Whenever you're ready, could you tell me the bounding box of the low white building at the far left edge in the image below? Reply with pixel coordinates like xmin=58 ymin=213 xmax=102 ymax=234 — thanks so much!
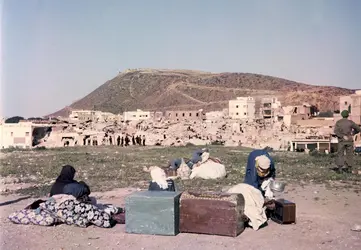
xmin=0 ymin=122 xmax=33 ymax=149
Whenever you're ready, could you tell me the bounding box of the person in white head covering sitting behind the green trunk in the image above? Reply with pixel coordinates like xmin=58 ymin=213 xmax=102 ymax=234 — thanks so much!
xmin=148 ymin=166 xmax=176 ymax=192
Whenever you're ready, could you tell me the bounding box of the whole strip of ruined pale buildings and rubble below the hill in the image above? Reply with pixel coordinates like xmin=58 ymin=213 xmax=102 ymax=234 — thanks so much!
xmin=0 ymin=91 xmax=361 ymax=151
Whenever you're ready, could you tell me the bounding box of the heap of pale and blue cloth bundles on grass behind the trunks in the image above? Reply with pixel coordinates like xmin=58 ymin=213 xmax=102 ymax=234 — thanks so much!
xmin=170 ymin=148 xmax=227 ymax=180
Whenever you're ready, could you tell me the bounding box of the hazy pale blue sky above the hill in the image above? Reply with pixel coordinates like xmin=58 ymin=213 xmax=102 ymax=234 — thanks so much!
xmin=0 ymin=0 xmax=361 ymax=117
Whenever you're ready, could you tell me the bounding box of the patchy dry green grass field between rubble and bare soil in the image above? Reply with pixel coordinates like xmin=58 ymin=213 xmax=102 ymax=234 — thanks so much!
xmin=0 ymin=146 xmax=361 ymax=195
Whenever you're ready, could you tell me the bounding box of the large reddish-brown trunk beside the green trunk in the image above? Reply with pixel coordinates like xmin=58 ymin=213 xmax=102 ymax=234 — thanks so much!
xmin=179 ymin=192 xmax=246 ymax=237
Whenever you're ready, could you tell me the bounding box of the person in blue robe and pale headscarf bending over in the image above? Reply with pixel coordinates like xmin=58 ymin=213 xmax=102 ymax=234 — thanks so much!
xmin=244 ymin=149 xmax=276 ymax=198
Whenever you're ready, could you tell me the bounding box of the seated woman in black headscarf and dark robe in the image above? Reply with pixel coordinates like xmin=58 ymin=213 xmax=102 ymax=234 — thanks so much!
xmin=50 ymin=165 xmax=90 ymax=201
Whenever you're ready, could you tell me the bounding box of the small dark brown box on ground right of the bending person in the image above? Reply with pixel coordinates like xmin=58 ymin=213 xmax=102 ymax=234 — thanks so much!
xmin=271 ymin=199 xmax=296 ymax=224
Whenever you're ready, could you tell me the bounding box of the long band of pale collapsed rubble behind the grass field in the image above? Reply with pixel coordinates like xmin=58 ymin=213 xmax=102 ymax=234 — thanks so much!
xmin=26 ymin=107 xmax=340 ymax=150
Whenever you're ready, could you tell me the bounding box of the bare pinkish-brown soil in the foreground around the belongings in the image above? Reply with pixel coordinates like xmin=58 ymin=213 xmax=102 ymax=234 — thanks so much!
xmin=0 ymin=186 xmax=361 ymax=250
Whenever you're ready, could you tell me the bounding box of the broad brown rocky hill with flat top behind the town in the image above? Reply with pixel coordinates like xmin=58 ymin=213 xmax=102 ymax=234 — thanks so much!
xmin=47 ymin=69 xmax=353 ymax=116
